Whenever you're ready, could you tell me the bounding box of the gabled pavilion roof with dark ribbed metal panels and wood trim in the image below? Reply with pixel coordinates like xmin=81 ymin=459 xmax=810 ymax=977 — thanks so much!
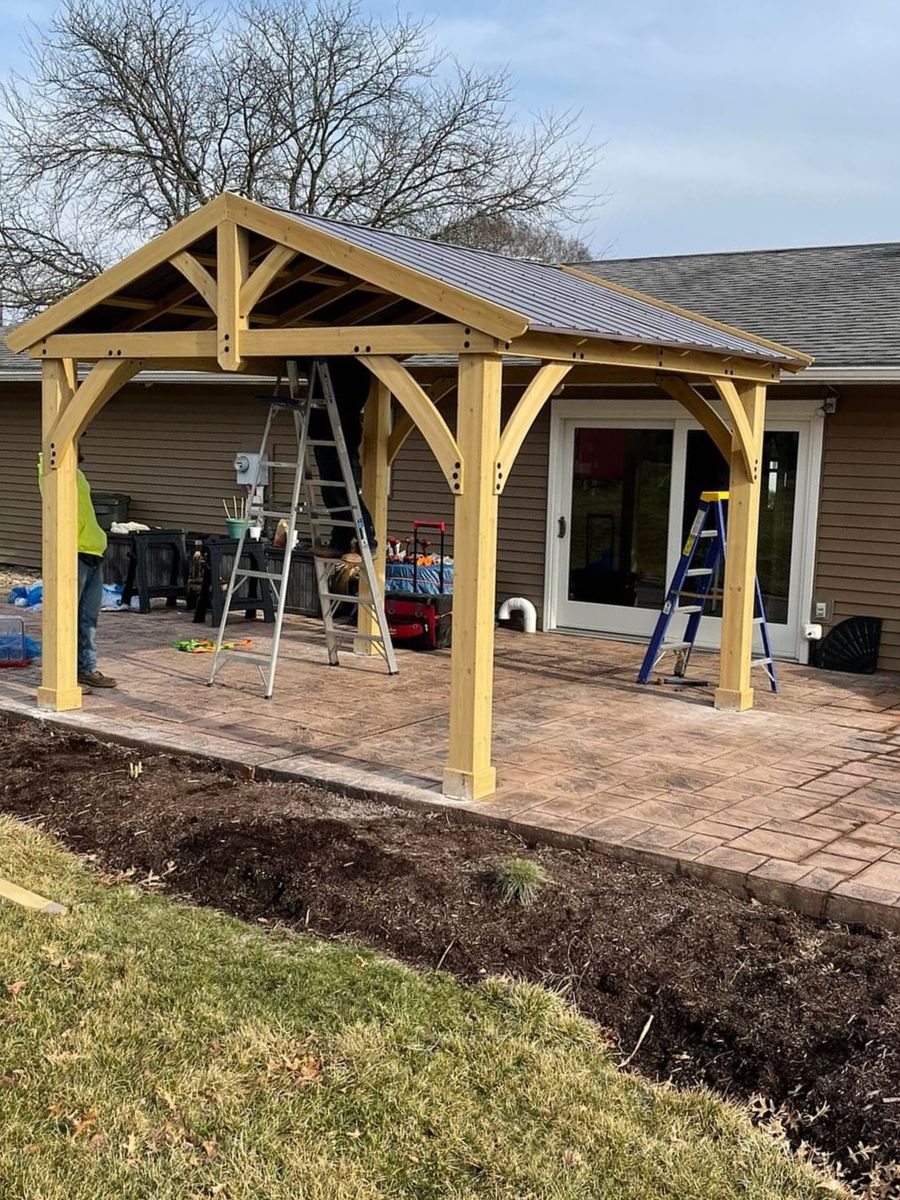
xmin=7 ymin=193 xmax=811 ymax=371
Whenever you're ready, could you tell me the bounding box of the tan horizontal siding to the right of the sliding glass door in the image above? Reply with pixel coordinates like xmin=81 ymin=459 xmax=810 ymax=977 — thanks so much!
xmin=814 ymin=386 xmax=900 ymax=671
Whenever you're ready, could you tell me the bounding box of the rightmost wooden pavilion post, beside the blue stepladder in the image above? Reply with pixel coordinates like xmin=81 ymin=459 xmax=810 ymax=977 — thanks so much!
xmin=715 ymin=383 xmax=766 ymax=712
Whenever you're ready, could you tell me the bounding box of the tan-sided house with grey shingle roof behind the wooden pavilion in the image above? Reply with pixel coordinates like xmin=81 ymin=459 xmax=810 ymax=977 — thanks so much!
xmin=0 ymin=236 xmax=900 ymax=686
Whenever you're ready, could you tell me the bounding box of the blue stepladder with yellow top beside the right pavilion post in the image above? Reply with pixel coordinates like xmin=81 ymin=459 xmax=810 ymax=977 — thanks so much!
xmin=637 ymin=492 xmax=778 ymax=692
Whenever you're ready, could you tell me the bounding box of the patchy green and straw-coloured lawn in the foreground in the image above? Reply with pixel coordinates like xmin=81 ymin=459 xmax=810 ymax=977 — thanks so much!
xmin=0 ymin=817 xmax=834 ymax=1200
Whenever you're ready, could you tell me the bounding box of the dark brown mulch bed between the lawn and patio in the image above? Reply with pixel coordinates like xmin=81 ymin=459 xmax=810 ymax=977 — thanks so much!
xmin=0 ymin=718 xmax=900 ymax=1190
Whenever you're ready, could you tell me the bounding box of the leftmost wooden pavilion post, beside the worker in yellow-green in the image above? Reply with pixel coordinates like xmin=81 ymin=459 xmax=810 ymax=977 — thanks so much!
xmin=37 ymin=359 xmax=82 ymax=713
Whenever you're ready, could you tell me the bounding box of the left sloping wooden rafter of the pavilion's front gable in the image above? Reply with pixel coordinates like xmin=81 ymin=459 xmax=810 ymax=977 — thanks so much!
xmin=6 ymin=196 xmax=226 ymax=352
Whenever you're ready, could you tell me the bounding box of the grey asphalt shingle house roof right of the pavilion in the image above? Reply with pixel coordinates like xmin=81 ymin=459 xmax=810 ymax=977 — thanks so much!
xmin=582 ymin=242 xmax=900 ymax=366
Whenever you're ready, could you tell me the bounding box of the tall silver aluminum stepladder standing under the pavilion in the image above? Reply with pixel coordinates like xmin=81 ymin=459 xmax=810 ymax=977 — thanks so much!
xmin=208 ymin=359 xmax=397 ymax=700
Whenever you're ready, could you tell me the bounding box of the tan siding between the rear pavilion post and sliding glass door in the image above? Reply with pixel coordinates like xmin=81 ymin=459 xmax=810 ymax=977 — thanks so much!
xmin=389 ymin=400 xmax=550 ymax=613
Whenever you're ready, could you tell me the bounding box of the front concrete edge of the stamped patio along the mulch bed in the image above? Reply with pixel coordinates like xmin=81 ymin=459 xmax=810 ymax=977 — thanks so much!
xmin=7 ymin=697 xmax=900 ymax=932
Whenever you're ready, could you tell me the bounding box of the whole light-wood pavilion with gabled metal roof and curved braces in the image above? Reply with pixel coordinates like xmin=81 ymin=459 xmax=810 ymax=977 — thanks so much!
xmin=7 ymin=194 xmax=811 ymax=799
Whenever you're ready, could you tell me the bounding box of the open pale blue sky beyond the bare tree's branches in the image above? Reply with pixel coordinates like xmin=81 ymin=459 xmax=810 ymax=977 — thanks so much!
xmin=0 ymin=0 xmax=900 ymax=257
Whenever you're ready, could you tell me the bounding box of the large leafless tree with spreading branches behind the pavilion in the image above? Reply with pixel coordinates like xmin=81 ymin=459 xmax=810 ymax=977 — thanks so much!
xmin=0 ymin=0 xmax=607 ymax=313
